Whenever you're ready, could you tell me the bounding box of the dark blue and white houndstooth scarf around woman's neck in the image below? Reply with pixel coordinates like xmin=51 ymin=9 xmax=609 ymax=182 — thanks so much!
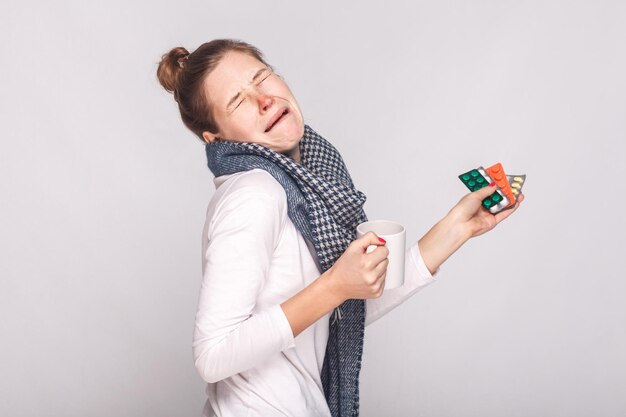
xmin=206 ymin=125 xmax=367 ymax=417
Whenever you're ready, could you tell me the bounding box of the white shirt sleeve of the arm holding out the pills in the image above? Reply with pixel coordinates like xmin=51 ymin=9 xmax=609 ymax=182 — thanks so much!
xmin=365 ymin=242 xmax=439 ymax=326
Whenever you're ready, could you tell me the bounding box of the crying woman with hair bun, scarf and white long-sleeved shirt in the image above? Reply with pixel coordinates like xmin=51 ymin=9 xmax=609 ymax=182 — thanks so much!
xmin=157 ymin=39 xmax=523 ymax=417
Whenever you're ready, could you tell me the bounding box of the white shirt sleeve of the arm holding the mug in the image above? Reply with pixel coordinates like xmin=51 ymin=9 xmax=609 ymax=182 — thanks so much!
xmin=192 ymin=184 xmax=295 ymax=382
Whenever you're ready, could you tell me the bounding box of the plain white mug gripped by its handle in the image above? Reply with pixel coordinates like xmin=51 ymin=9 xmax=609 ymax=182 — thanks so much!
xmin=356 ymin=220 xmax=406 ymax=289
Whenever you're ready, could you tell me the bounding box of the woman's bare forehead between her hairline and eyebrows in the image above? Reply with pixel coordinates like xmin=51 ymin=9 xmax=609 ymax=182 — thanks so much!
xmin=204 ymin=52 xmax=265 ymax=105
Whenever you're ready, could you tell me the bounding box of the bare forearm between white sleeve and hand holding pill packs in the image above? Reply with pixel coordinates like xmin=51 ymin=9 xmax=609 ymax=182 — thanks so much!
xmin=417 ymin=215 xmax=471 ymax=274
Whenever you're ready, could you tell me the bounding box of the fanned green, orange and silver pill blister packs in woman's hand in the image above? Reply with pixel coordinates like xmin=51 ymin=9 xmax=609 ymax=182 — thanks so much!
xmin=459 ymin=162 xmax=526 ymax=214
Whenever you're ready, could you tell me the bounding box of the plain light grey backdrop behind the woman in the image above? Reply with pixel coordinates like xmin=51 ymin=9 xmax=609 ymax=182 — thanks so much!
xmin=0 ymin=0 xmax=626 ymax=417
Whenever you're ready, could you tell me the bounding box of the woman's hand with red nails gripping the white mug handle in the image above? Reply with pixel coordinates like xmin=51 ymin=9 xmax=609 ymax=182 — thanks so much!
xmin=324 ymin=232 xmax=389 ymax=305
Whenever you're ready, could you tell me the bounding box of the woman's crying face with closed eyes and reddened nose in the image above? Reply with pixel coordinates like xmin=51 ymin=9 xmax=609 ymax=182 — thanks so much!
xmin=202 ymin=52 xmax=304 ymax=162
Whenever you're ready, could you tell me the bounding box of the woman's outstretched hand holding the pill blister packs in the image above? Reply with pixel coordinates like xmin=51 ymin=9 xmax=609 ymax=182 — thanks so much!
xmin=448 ymin=186 xmax=524 ymax=238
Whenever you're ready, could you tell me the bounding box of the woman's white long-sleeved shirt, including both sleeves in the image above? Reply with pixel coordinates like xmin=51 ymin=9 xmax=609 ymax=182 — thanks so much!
xmin=192 ymin=169 xmax=437 ymax=417
